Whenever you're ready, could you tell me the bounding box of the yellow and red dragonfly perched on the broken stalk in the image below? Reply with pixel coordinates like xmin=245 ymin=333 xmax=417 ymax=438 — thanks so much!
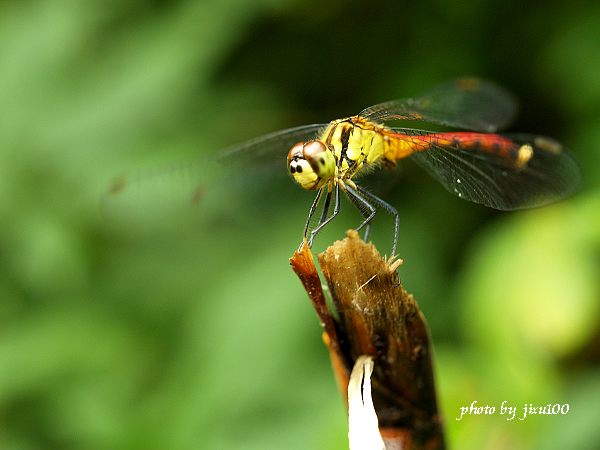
xmin=109 ymin=78 xmax=581 ymax=256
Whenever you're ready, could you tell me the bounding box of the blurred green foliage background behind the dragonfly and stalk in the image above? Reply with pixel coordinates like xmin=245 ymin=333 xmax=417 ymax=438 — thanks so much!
xmin=0 ymin=0 xmax=600 ymax=450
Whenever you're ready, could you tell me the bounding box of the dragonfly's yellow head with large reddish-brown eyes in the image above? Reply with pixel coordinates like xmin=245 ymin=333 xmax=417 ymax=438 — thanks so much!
xmin=288 ymin=140 xmax=336 ymax=189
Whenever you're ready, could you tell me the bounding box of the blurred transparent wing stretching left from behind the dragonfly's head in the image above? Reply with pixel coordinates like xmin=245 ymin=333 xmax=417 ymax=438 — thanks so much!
xmin=101 ymin=124 xmax=326 ymax=221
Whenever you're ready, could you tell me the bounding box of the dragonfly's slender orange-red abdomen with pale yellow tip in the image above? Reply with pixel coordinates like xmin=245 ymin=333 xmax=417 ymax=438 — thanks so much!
xmin=385 ymin=130 xmax=532 ymax=167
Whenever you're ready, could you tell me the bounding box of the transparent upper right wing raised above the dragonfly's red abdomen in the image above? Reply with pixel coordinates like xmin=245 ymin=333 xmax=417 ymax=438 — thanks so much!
xmin=359 ymin=78 xmax=517 ymax=132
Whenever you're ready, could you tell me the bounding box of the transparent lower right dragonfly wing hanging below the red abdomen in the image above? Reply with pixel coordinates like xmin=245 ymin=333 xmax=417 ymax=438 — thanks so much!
xmin=410 ymin=130 xmax=581 ymax=210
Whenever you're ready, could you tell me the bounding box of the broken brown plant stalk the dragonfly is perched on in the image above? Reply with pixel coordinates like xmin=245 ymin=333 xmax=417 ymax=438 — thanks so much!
xmin=290 ymin=231 xmax=444 ymax=450
